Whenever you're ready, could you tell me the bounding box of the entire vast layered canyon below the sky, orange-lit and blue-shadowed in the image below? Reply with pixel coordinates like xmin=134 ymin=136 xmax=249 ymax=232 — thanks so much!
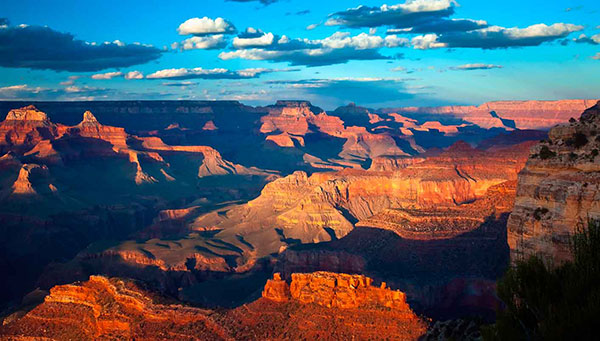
xmin=0 ymin=100 xmax=600 ymax=339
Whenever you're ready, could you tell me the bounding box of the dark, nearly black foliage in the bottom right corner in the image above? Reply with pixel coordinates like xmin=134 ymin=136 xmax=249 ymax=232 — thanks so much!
xmin=482 ymin=221 xmax=600 ymax=340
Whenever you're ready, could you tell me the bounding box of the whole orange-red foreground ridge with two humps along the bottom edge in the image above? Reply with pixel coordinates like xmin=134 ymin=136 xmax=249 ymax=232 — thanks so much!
xmin=0 ymin=273 xmax=426 ymax=340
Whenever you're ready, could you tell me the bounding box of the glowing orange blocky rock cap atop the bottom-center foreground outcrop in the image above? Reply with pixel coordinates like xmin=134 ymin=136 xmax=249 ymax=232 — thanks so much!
xmin=262 ymin=271 xmax=416 ymax=310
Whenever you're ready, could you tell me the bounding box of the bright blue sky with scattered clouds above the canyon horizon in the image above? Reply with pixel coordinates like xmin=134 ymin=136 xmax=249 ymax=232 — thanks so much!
xmin=0 ymin=0 xmax=600 ymax=109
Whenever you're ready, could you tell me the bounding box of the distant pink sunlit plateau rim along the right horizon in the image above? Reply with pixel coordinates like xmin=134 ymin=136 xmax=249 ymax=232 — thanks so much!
xmin=384 ymin=100 xmax=596 ymax=130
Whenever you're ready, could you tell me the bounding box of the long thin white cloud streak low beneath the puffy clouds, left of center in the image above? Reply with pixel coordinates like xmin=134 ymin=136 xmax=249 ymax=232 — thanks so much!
xmin=146 ymin=67 xmax=297 ymax=80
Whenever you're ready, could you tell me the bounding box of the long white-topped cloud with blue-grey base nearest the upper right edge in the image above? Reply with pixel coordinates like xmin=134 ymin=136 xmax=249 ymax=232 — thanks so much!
xmin=411 ymin=23 xmax=583 ymax=49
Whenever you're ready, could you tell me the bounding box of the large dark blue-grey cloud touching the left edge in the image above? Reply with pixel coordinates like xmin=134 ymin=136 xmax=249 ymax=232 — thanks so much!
xmin=0 ymin=25 xmax=162 ymax=72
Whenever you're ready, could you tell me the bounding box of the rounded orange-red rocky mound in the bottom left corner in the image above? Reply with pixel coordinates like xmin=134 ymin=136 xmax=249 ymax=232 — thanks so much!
xmin=0 ymin=276 xmax=230 ymax=340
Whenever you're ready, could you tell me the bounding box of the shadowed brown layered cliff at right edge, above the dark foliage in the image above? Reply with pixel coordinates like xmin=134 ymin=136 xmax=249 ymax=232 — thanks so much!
xmin=508 ymin=100 xmax=600 ymax=262
